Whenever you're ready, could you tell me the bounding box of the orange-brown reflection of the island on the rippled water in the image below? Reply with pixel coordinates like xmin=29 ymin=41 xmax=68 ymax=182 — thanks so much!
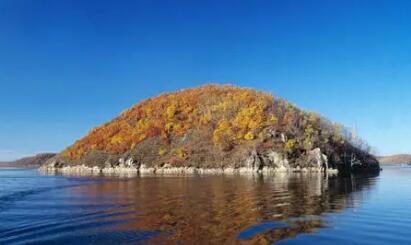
xmin=82 ymin=174 xmax=380 ymax=244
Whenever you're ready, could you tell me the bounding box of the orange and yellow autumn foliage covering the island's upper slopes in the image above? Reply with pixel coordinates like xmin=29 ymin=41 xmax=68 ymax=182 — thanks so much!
xmin=63 ymin=85 xmax=342 ymax=159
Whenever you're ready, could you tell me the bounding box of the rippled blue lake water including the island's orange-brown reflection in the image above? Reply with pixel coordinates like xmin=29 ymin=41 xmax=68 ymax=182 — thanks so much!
xmin=0 ymin=166 xmax=411 ymax=244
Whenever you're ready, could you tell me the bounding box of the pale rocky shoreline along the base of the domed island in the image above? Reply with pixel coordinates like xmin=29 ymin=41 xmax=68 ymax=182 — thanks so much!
xmin=41 ymin=148 xmax=338 ymax=175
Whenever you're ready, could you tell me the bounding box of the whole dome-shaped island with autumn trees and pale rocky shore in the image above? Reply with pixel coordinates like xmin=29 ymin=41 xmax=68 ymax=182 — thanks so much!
xmin=42 ymin=85 xmax=380 ymax=174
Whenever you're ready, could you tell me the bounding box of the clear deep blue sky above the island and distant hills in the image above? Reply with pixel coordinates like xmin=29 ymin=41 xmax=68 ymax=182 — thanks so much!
xmin=0 ymin=0 xmax=411 ymax=160
